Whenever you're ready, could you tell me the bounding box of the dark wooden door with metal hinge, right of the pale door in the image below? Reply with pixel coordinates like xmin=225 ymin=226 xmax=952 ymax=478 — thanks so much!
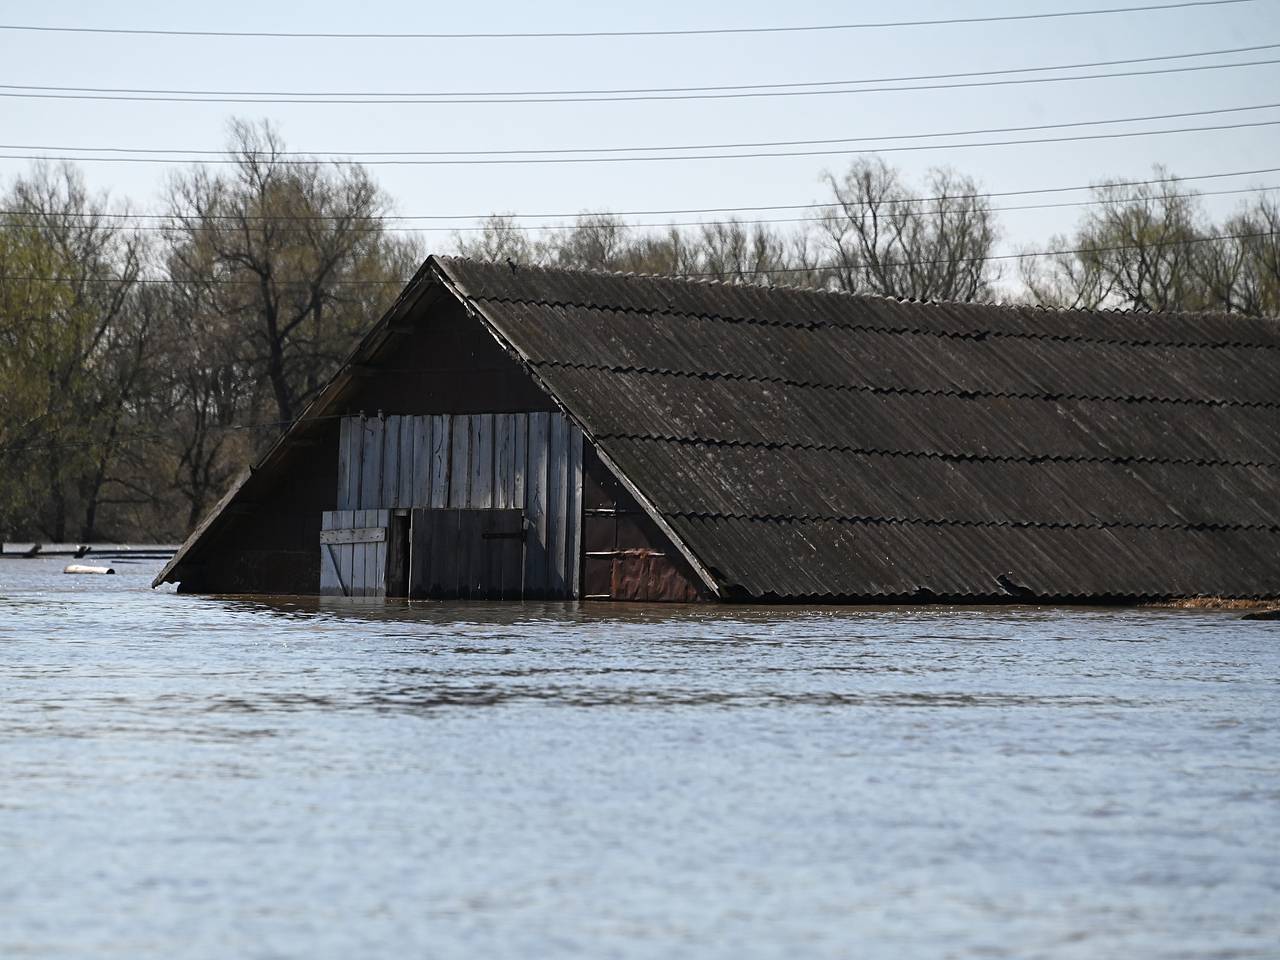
xmin=408 ymin=508 xmax=525 ymax=600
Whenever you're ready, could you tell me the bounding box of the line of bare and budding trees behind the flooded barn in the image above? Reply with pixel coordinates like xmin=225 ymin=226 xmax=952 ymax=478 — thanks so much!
xmin=0 ymin=120 xmax=1280 ymax=541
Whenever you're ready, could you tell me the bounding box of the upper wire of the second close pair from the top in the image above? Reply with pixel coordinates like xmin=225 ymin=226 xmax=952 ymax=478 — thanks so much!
xmin=0 ymin=102 xmax=1280 ymax=164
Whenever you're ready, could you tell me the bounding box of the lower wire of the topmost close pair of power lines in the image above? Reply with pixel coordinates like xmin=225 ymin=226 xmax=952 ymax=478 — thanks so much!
xmin=0 ymin=59 xmax=1280 ymax=106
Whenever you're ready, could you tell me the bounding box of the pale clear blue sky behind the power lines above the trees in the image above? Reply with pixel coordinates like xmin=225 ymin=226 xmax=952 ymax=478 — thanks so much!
xmin=0 ymin=0 xmax=1280 ymax=271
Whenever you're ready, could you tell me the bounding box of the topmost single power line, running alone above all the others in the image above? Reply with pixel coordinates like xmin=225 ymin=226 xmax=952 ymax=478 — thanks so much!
xmin=0 ymin=0 xmax=1254 ymax=40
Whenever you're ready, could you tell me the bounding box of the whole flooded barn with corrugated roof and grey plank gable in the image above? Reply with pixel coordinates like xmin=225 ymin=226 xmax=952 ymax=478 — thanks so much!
xmin=156 ymin=257 xmax=1280 ymax=603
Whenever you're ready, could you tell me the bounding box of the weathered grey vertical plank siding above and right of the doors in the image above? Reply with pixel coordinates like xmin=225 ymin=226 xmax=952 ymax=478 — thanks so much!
xmin=337 ymin=412 xmax=582 ymax=599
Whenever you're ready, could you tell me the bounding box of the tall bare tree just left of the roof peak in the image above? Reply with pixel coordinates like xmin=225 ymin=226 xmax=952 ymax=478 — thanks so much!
xmin=168 ymin=120 xmax=416 ymax=421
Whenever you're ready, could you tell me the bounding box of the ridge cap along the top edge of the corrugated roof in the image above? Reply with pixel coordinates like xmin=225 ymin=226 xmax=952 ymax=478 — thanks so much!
xmin=434 ymin=255 xmax=1280 ymax=335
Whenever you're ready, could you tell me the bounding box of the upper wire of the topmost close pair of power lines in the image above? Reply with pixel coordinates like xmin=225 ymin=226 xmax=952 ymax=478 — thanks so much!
xmin=0 ymin=44 xmax=1280 ymax=101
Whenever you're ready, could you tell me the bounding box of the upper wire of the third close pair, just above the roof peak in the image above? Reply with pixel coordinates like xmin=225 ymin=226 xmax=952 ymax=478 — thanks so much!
xmin=0 ymin=166 xmax=1280 ymax=229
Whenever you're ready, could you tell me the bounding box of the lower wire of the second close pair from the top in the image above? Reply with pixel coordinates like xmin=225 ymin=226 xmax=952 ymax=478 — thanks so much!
xmin=0 ymin=120 xmax=1280 ymax=166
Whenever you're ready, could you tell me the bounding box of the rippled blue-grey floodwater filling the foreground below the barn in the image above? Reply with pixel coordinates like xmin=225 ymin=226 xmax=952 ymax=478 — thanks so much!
xmin=0 ymin=561 xmax=1280 ymax=960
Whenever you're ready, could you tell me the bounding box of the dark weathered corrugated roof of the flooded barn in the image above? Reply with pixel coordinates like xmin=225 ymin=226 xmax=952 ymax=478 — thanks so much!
xmin=154 ymin=257 xmax=1280 ymax=600
